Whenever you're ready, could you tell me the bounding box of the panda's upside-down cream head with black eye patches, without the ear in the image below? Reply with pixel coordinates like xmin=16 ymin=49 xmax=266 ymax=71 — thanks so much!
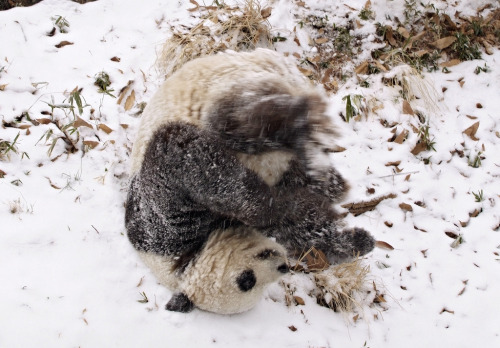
xmin=183 ymin=227 xmax=289 ymax=314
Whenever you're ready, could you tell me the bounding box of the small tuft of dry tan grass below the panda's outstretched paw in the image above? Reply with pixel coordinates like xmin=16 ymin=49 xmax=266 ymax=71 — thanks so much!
xmin=314 ymin=258 xmax=370 ymax=312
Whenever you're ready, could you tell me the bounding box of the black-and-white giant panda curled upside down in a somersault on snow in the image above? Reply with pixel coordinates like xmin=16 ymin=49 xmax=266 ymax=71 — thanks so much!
xmin=125 ymin=49 xmax=374 ymax=313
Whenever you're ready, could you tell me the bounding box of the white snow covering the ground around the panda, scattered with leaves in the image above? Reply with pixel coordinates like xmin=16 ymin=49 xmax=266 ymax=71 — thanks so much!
xmin=0 ymin=0 xmax=500 ymax=347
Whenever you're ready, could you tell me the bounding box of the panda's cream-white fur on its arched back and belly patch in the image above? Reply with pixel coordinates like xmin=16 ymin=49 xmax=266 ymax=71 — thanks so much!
xmin=131 ymin=49 xmax=334 ymax=179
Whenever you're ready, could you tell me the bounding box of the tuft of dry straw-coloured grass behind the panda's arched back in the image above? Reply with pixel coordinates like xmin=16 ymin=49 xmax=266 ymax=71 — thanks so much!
xmin=157 ymin=0 xmax=272 ymax=78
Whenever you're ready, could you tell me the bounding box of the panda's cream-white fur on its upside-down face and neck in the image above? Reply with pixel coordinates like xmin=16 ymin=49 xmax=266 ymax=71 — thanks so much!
xmin=139 ymin=227 xmax=286 ymax=314
